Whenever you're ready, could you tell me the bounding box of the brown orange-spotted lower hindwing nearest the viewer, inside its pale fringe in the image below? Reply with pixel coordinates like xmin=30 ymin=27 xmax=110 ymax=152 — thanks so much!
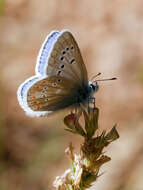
xmin=27 ymin=76 xmax=80 ymax=111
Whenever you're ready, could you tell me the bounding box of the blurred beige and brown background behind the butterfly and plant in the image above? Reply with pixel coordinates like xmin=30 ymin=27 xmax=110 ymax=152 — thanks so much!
xmin=0 ymin=0 xmax=143 ymax=190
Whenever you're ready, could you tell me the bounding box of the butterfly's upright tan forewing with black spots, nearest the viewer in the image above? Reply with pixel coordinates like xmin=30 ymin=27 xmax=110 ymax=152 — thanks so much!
xmin=38 ymin=31 xmax=88 ymax=84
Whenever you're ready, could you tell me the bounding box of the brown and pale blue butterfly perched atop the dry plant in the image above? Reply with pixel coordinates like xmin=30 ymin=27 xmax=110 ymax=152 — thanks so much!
xmin=17 ymin=30 xmax=101 ymax=116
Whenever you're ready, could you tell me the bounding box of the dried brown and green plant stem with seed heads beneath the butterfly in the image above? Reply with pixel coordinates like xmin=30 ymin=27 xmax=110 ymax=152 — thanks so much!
xmin=54 ymin=108 xmax=119 ymax=190
